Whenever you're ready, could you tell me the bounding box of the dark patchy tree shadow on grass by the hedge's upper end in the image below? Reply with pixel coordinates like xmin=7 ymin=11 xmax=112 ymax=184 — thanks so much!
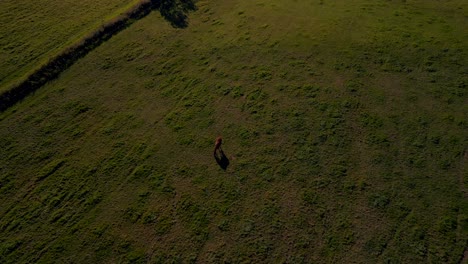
xmin=153 ymin=0 xmax=197 ymax=28
